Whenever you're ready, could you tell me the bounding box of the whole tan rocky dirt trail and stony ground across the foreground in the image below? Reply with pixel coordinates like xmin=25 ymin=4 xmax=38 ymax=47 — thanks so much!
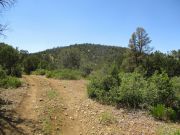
xmin=0 ymin=75 xmax=180 ymax=135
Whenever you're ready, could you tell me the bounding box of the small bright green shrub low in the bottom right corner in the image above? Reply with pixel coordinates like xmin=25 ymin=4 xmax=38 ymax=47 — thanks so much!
xmin=151 ymin=104 xmax=177 ymax=120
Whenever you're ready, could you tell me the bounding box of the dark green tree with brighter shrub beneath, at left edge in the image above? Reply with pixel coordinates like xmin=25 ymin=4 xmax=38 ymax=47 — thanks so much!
xmin=0 ymin=43 xmax=22 ymax=88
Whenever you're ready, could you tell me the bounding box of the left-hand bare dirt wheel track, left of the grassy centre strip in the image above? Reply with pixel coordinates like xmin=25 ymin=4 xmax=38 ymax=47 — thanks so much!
xmin=15 ymin=76 xmax=38 ymax=135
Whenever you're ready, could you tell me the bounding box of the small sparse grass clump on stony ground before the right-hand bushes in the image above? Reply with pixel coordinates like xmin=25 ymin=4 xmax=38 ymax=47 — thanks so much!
xmin=100 ymin=112 xmax=116 ymax=125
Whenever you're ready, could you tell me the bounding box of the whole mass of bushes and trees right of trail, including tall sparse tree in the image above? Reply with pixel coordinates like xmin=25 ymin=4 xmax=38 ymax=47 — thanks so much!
xmin=88 ymin=28 xmax=180 ymax=121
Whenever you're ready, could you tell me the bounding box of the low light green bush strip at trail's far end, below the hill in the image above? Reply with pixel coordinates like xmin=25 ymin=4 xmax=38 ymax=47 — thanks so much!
xmin=46 ymin=69 xmax=82 ymax=80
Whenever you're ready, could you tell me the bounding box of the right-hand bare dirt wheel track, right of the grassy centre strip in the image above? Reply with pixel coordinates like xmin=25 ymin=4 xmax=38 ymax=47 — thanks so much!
xmin=42 ymin=77 xmax=87 ymax=135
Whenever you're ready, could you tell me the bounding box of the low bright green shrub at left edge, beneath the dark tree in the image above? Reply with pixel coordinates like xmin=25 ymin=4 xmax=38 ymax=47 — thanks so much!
xmin=0 ymin=76 xmax=21 ymax=88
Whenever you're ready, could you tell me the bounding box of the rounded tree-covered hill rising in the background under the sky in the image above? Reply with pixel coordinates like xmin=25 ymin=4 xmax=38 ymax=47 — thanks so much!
xmin=31 ymin=43 xmax=127 ymax=69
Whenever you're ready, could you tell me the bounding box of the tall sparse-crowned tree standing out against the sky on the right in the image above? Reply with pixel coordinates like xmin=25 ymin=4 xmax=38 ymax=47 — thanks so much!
xmin=121 ymin=27 xmax=152 ymax=72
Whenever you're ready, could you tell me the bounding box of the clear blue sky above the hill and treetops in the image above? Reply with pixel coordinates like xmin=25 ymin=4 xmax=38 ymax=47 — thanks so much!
xmin=0 ymin=0 xmax=180 ymax=53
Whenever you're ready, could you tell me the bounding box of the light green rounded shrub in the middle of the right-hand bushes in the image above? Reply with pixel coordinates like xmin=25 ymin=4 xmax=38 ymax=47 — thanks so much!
xmin=118 ymin=72 xmax=147 ymax=108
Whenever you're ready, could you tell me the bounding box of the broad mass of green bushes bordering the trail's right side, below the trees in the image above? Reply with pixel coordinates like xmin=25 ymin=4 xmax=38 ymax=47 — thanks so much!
xmin=88 ymin=69 xmax=180 ymax=120
